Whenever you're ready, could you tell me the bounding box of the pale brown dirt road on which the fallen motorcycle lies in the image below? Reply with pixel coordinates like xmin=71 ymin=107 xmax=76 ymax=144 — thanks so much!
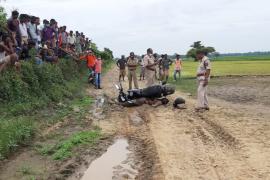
xmin=93 ymin=66 xmax=270 ymax=180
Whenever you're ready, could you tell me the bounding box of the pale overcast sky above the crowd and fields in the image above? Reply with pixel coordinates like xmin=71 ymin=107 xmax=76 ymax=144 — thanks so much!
xmin=0 ymin=0 xmax=270 ymax=56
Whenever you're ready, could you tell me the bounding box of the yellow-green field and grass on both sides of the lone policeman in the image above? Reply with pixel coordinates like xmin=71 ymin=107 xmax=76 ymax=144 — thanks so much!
xmin=170 ymin=56 xmax=270 ymax=95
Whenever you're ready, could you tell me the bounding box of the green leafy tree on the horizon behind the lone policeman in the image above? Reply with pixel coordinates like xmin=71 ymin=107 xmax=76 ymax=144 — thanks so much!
xmin=187 ymin=41 xmax=216 ymax=60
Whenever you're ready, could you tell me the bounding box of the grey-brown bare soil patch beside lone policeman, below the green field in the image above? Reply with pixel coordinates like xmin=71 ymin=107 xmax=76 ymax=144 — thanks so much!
xmin=209 ymin=76 xmax=270 ymax=106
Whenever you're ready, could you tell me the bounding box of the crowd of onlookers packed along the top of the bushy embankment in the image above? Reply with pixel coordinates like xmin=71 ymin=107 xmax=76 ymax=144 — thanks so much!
xmin=0 ymin=10 xmax=102 ymax=88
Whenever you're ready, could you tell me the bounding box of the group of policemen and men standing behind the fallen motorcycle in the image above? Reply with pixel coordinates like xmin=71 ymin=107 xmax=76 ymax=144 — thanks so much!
xmin=116 ymin=49 xmax=183 ymax=89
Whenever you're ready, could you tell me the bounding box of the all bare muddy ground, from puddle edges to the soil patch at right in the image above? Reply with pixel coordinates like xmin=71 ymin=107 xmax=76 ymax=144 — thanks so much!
xmin=0 ymin=68 xmax=270 ymax=180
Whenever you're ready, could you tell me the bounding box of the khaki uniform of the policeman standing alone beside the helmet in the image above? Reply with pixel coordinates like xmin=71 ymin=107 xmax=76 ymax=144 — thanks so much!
xmin=197 ymin=56 xmax=211 ymax=108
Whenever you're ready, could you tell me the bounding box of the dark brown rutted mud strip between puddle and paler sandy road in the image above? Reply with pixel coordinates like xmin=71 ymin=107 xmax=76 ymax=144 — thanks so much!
xmin=91 ymin=102 xmax=164 ymax=180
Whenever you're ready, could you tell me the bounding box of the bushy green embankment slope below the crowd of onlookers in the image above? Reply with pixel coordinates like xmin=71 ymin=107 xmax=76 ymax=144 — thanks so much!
xmin=0 ymin=59 xmax=112 ymax=159
